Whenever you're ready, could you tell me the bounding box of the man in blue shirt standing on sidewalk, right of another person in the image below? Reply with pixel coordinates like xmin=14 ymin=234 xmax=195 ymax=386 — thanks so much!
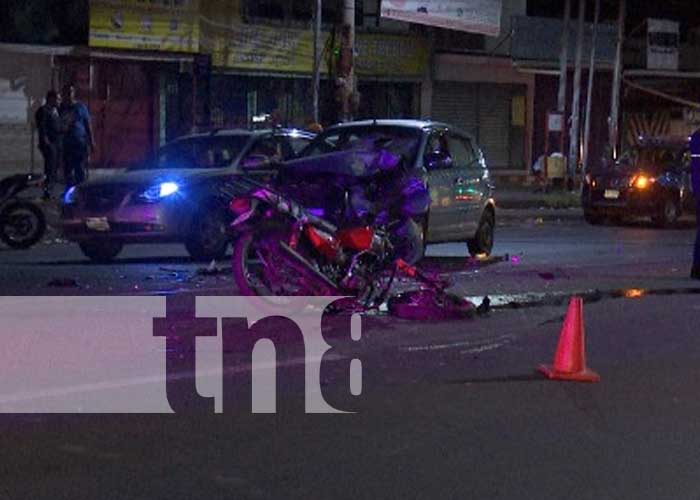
xmin=60 ymin=84 xmax=95 ymax=188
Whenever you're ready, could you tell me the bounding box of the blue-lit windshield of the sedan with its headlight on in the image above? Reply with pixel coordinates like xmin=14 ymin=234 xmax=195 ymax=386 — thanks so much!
xmin=136 ymin=135 xmax=249 ymax=169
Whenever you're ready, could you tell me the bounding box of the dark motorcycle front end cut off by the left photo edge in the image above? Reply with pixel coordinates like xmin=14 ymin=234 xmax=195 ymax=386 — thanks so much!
xmin=0 ymin=174 xmax=46 ymax=249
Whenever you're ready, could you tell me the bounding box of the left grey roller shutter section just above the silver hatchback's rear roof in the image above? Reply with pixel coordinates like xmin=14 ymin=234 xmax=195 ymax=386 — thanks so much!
xmin=432 ymin=82 xmax=478 ymax=137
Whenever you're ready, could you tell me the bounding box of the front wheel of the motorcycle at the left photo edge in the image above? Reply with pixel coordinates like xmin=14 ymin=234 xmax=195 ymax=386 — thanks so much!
xmin=0 ymin=201 xmax=46 ymax=249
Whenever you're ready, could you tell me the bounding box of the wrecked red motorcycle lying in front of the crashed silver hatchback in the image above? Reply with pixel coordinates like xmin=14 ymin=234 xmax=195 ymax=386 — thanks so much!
xmin=230 ymin=180 xmax=474 ymax=320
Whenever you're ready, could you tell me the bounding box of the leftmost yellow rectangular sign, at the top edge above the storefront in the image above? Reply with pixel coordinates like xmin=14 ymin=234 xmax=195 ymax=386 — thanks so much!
xmin=90 ymin=0 xmax=199 ymax=53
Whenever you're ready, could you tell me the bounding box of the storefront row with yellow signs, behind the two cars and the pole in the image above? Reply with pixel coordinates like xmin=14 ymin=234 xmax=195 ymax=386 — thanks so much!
xmin=84 ymin=0 xmax=429 ymax=168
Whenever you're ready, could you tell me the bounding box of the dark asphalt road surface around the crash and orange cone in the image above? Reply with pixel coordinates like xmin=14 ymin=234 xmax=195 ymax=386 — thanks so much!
xmin=0 ymin=217 xmax=700 ymax=500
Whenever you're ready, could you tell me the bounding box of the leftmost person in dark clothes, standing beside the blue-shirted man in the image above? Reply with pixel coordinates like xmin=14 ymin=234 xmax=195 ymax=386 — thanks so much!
xmin=34 ymin=90 xmax=61 ymax=200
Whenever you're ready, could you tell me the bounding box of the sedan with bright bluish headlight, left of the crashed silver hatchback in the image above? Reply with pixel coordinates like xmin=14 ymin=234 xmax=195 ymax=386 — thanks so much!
xmin=62 ymin=129 xmax=314 ymax=262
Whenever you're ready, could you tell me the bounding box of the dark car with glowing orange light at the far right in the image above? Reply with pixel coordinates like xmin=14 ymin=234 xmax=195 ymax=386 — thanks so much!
xmin=581 ymin=141 xmax=692 ymax=227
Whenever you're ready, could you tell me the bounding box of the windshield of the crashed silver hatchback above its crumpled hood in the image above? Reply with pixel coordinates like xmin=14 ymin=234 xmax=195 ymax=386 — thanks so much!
xmin=301 ymin=125 xmax=421 ymax=159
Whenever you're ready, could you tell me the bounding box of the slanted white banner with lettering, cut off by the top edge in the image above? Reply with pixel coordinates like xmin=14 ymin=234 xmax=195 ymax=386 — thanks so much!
xmin=381 ymin=0 xmax=502 ymax=36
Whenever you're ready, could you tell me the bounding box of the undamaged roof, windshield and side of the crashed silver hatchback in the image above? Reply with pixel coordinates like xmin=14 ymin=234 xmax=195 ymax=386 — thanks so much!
xmin=299 ymin=120 xmax=496 ymax=255
